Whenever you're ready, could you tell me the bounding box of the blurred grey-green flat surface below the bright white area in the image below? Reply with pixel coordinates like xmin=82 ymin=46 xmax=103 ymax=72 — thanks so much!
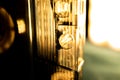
xmin=83 ymin=41 xmax=120 ymax=80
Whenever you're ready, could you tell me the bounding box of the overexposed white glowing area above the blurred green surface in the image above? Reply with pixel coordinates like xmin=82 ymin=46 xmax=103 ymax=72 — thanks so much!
xmin=88 ymin=0 xmax=120 ymax=50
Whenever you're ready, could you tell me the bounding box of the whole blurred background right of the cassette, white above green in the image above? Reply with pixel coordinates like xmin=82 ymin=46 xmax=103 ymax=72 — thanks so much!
xmin=83 ymin=0 xmax=120 ymax=80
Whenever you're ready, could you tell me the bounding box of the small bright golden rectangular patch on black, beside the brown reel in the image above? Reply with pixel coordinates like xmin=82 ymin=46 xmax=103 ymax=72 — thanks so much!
xmin=17 ymin=19 xmax=26 ymax=34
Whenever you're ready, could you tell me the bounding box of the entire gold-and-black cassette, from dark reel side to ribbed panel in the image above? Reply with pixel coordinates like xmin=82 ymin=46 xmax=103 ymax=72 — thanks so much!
xmin=0 ymin=0 xmax=86 ymax=80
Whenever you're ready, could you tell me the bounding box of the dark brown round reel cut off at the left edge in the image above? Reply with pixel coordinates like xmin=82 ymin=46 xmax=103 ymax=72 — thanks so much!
xmin=0 ymin=7 xmax=15 ymax=54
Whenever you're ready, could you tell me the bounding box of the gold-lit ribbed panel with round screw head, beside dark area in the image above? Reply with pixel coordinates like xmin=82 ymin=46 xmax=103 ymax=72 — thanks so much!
xmin=35 ymin=0 xmax=86 ymax=72
